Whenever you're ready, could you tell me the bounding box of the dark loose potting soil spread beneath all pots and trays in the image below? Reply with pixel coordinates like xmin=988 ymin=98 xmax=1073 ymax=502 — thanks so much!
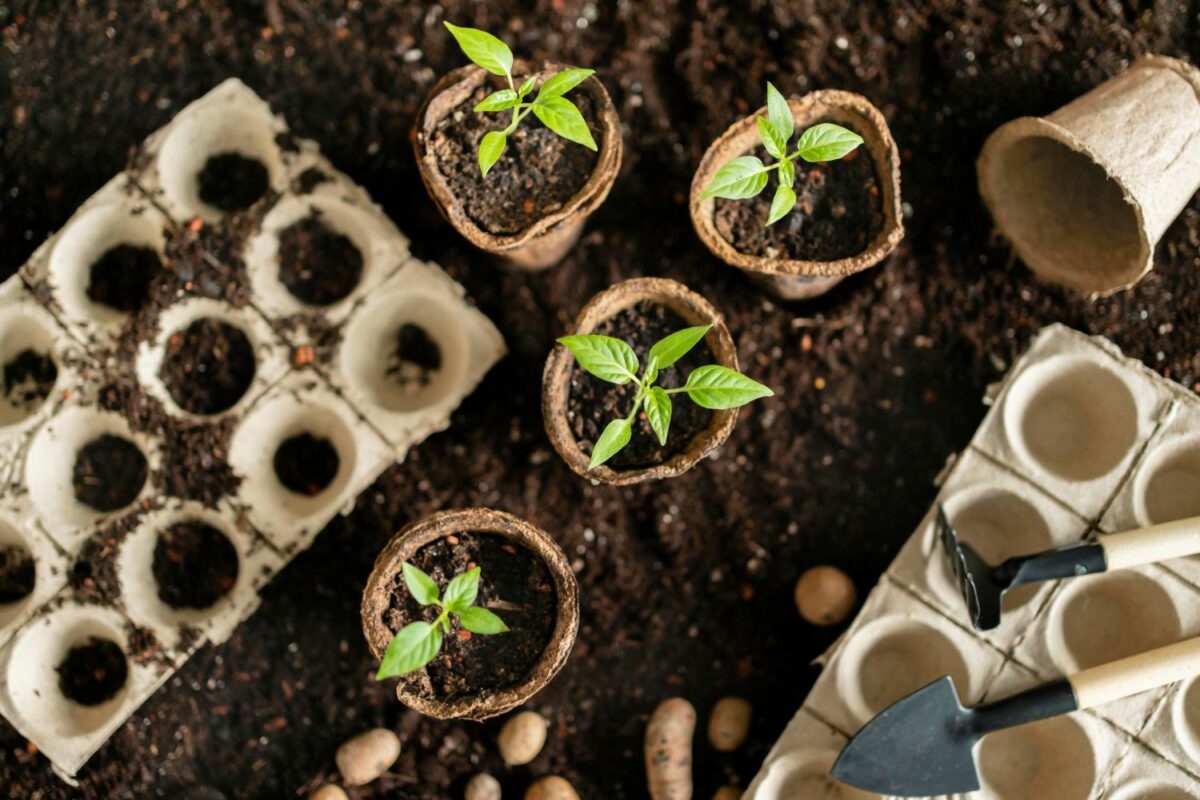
xmin=0 ymin=0 xmax=1200 ymax=800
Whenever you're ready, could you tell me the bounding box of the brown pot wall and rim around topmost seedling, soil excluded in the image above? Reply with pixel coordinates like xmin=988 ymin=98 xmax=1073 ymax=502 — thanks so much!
xmin=413 ymin=61 xmax=622 ymax=270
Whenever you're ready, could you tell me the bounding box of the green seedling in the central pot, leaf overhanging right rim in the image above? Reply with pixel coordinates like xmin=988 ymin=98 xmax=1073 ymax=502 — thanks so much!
xmin=558 ymin=325 xmax=775 ymax=469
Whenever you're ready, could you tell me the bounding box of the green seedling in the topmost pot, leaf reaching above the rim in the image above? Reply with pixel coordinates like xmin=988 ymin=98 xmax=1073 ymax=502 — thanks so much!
xmin=445 ymin=23 xmax=596 ymax=178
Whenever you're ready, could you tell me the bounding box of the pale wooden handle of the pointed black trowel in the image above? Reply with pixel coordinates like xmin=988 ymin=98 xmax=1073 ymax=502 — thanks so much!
xmin=1067 ymin=636 xmax=1200 ymax=709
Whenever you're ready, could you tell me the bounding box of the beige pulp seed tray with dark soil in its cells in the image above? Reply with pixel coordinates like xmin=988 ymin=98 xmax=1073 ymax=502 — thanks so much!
xmin=0 ymin=80 xmax=504 ymax=777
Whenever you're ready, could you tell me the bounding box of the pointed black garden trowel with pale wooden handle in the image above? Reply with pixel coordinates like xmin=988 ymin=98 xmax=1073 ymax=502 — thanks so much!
xmin=830 ymin=637 xmax=1200 ymax=798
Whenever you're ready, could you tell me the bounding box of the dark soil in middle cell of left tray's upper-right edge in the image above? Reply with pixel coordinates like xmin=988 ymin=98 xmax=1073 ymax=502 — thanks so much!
xmin=280 ymin=212 xmax=362 ymax=306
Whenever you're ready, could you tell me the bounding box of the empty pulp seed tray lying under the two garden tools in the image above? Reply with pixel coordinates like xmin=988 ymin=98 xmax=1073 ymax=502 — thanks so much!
xmin=746 ymin=325 xmax=1200 ymax=800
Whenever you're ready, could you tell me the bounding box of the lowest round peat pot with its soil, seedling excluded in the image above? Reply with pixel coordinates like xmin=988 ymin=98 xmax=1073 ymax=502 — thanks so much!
xmin=362 ymin=509 xmax=580 ymax=721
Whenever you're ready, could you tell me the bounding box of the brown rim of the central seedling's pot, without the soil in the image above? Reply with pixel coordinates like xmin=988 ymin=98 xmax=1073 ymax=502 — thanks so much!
xmin=541 ymin=278 xmax=738 ymax=486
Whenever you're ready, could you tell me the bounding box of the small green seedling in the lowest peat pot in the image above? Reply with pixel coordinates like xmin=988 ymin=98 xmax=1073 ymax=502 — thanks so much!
xmin=376 ymin=563 xmax=509 ymax=680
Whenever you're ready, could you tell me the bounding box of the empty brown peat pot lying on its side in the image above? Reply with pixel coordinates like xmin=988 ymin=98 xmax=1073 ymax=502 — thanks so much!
xmin=978 ymin=55 xmax=1200 ymax=295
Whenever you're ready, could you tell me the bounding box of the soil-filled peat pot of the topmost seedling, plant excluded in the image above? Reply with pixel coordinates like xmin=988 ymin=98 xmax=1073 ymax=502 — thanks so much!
xmin=413 ymin=61 xmax=622 ymax=270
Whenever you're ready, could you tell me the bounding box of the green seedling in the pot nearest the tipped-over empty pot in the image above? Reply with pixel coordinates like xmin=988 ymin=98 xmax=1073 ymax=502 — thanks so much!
xmin=700 ymin=83 xmax=863 ymax=225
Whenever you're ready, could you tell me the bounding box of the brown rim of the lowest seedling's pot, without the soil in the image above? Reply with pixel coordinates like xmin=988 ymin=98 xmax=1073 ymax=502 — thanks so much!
xmin=362 ymin=509 xmax=580 ymax=721
